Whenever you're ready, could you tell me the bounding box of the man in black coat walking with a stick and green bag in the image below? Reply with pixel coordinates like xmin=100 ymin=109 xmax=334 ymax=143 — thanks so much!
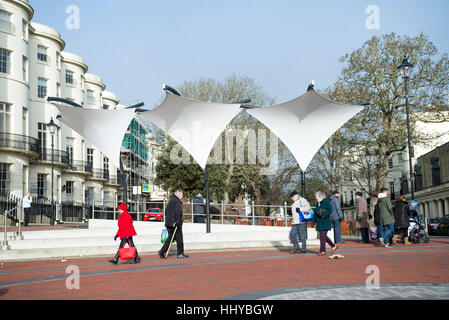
xmin=158 ymin=190 xmax=189 ymax=259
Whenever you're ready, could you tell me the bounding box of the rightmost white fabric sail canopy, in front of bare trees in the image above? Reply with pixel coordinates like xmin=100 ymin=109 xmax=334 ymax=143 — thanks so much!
xmin=247 ymin=90 xmax=363 ymax=171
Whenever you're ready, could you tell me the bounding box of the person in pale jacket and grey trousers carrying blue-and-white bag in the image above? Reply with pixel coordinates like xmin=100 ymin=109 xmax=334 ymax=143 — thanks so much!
xmin=290 ymin=190 xmax=310 ymax=254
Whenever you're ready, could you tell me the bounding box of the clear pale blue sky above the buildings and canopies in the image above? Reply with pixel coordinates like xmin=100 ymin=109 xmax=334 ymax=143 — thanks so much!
xmin=30 ymin=0 xmax=449 ymax=107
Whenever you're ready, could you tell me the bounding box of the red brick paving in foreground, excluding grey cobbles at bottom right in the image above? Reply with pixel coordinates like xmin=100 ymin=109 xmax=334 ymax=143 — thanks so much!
xmin=0 ymin=238 xmax=449 ymax=300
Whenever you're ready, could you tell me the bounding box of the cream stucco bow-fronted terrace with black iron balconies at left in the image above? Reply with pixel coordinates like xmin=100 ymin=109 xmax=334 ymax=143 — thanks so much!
xmin=0 ymin=0 xmax=152 ymax=222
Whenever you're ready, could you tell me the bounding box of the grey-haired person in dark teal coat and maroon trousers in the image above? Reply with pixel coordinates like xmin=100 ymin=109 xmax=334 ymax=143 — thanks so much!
xmin=312 ymin=191 xmax=338 ymax=256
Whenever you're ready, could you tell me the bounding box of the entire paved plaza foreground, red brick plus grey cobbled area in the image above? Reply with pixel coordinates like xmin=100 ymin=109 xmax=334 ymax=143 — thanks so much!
xmin=0 ymin=237 xmax=449 ymax=300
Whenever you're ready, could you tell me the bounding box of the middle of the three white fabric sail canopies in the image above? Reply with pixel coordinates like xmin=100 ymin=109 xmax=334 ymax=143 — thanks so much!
xmin=141 ymin=93 xmax=240 ymax=170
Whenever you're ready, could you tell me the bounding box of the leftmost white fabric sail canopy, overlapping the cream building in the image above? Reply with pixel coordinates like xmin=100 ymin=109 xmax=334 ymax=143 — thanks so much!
xmin=52 ymin=102 xmax=135 ymax=168
